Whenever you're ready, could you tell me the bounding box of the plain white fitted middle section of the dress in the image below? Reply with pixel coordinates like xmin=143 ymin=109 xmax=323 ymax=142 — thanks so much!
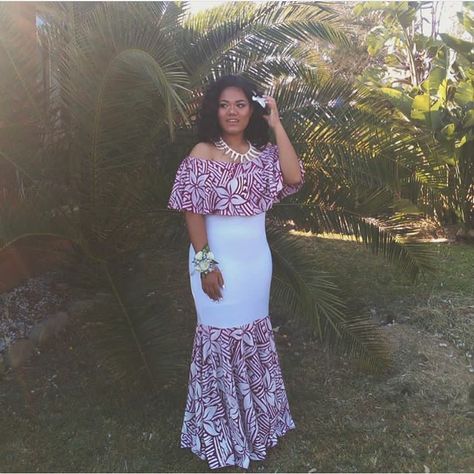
xmin=188 ymin=212 xmax=272 ymax=328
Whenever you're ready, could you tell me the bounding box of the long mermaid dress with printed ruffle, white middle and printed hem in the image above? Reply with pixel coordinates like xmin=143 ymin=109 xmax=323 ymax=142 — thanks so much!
xmin=168 ymin=144 xmax=304 ymax=469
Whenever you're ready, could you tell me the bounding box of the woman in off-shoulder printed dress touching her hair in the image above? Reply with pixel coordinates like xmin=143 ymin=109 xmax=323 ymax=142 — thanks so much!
xmin=168 ymin=76 xmax=304 ymax=469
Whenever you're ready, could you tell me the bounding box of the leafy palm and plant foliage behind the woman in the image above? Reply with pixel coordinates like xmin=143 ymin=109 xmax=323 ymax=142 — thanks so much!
xmin=0 ymin=2 xmax=473 ymax=392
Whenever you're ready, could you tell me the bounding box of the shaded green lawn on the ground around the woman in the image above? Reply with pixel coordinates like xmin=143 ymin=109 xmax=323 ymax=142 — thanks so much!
xmin=0 ymin=236 xmax=474 ymax=472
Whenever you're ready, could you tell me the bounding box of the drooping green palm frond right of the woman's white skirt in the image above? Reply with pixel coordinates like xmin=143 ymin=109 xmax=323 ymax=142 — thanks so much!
xmin=267 ymin=225 xmax=391 ymax=371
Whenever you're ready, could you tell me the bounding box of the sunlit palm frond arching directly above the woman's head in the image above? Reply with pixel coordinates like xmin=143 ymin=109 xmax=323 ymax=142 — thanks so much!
xmin=181 ymin=2 xmax=347 ymax=85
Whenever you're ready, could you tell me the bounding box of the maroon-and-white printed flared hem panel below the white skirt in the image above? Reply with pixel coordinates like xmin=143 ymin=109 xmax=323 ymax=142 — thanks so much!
xmin=180 ymin=316 xmax=295 ymax=469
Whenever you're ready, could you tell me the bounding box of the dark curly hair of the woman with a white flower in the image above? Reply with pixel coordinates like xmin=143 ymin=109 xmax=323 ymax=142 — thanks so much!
xmin=197 ymin=75 xmax=269 ymax=149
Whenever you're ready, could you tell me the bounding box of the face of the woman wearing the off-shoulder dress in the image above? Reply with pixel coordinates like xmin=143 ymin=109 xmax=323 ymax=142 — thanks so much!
xmin=217 ymin=87 xmax=253 ymax=135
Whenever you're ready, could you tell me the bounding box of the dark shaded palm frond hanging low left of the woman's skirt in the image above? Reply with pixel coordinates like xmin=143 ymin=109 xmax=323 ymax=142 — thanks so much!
xmin=63 ymin=254 xmax=192 ymax=395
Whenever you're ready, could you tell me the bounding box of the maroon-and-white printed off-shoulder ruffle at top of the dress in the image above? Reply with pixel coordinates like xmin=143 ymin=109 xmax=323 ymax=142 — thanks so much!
xmin=168 ymin=145 xmax=304 ymax=216
